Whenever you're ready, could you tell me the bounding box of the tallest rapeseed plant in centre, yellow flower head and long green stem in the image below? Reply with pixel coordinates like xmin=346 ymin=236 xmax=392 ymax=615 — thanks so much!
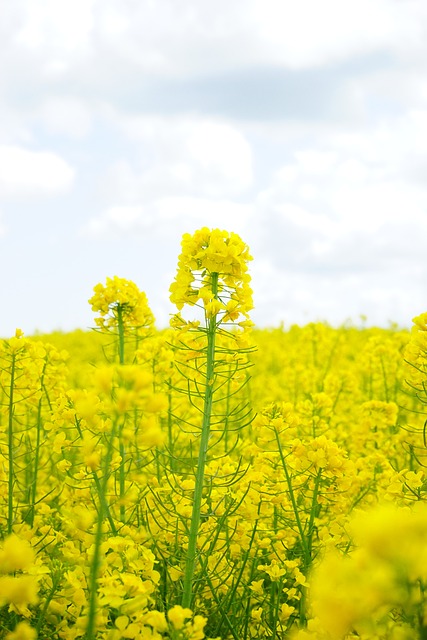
xmin=170 ymin=228 xmax=252 ymax=608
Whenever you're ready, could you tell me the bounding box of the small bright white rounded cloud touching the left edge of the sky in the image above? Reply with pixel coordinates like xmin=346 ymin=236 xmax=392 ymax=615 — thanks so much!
xmin=0 ymin=145 xmax=75 ymax=198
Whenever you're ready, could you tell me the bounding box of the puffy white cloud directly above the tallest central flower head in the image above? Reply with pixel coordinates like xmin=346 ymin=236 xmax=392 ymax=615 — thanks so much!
xmin=108 ymin=117 xmax=253 ymax=201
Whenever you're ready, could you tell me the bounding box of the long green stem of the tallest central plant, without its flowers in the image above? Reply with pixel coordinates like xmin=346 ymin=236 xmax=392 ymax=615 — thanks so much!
xmin=181 ymin=273 xmax=218 ymax=608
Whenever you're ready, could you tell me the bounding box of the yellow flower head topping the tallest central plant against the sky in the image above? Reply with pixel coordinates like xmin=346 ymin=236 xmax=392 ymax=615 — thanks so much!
xmin=170 ymin=227 xmax=253 ymax=322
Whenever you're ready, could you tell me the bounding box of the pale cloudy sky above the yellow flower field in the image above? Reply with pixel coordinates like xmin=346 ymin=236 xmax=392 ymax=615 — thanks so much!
xmin=0 ymin=0 xmax=427 ymax=337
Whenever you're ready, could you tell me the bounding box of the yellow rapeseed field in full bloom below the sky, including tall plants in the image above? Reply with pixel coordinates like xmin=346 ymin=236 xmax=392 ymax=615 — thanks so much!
xmin=0 ymin=229 xmax=427 ymax=640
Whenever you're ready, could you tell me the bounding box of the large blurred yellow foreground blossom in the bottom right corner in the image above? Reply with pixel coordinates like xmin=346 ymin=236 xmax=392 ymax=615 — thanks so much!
xmin=312 ymin=502 xmax=427 ymax=640
